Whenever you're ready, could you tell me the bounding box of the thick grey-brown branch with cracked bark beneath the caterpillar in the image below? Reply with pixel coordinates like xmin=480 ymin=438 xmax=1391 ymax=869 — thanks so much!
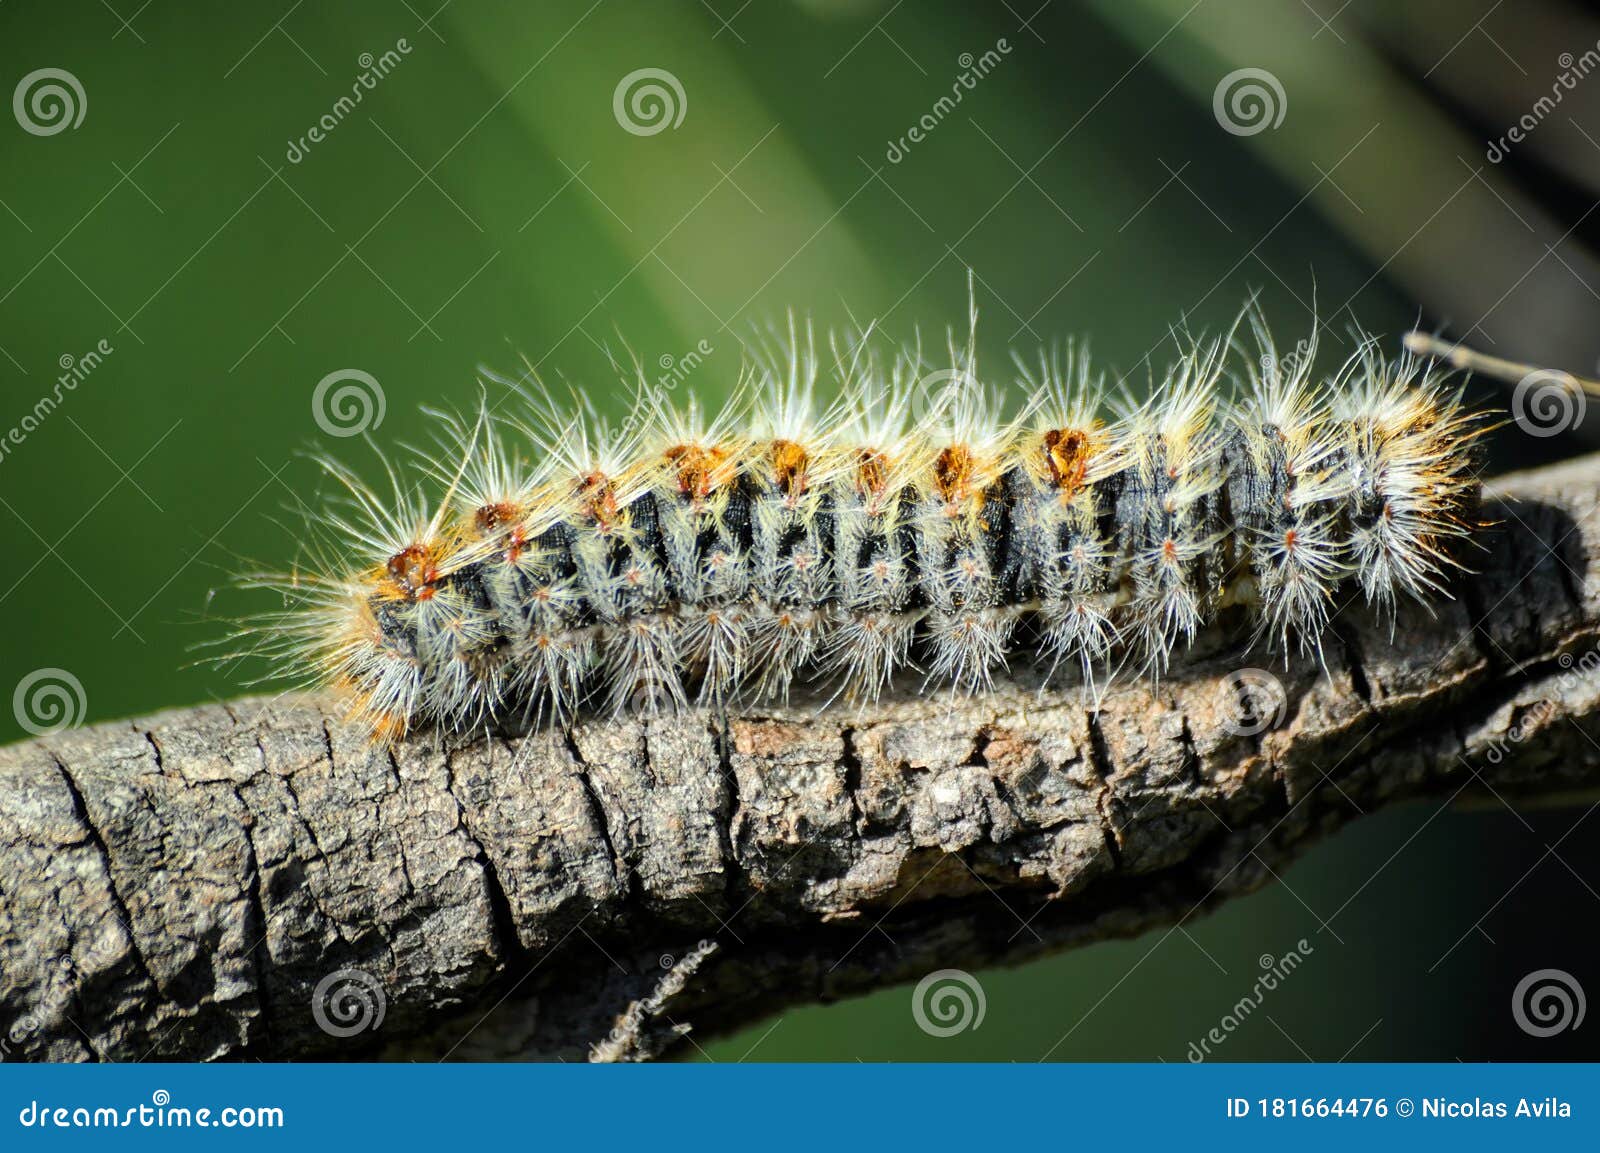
xmin=9 ymin=457 xmax=1600 ymax=1060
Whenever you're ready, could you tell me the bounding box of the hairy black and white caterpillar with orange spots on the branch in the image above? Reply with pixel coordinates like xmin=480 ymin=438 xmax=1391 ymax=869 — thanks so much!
xmin=243 ymin=305 xmax=1486 ymax=740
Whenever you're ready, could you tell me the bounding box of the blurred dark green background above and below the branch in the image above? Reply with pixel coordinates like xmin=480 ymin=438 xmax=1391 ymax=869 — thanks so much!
xmin=0 ymin=0 xmax=1600 ymax=1060
